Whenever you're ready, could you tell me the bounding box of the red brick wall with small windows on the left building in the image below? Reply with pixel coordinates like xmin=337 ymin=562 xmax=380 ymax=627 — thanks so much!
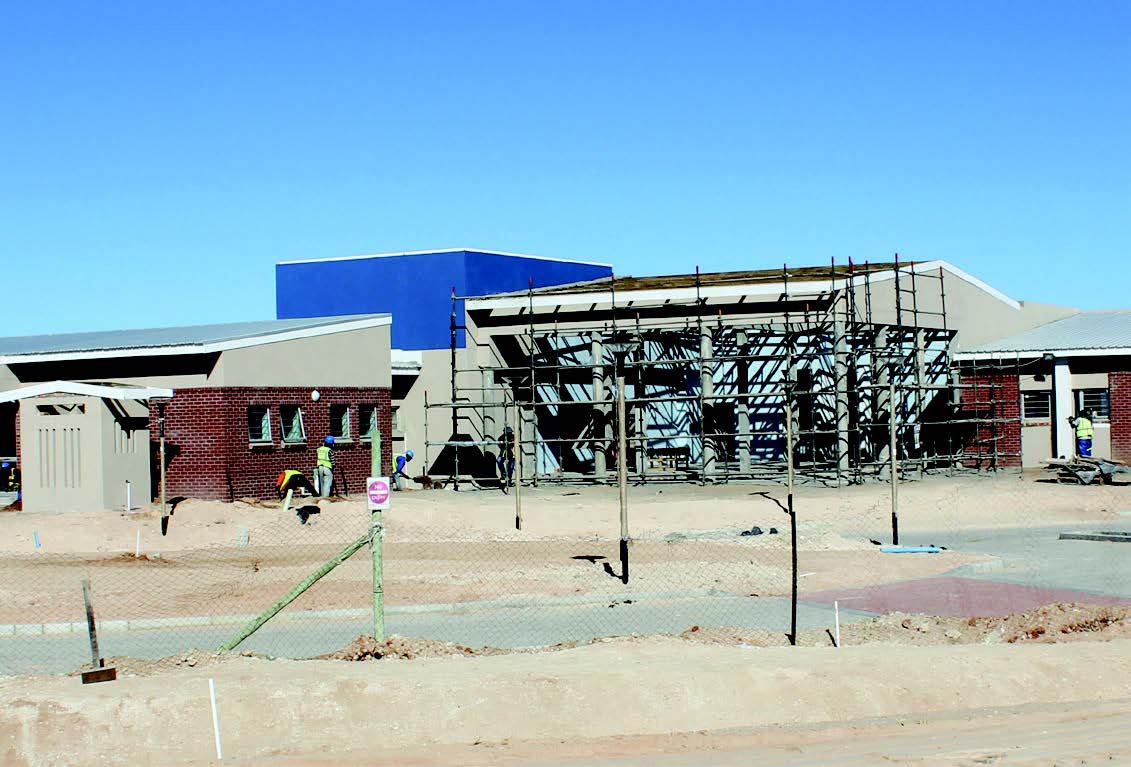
xmin=149 ymin=387 xmax=392 ymax=500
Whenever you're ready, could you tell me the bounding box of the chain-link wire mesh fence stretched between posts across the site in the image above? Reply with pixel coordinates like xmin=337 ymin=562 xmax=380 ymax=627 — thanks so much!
xmin=0 ymin=472 xmax=1131 ymax=674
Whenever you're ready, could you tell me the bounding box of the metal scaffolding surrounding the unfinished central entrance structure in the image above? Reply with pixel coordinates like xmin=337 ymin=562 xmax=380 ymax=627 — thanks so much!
xmin=425 ymin=256 xmax=1021 ymax=488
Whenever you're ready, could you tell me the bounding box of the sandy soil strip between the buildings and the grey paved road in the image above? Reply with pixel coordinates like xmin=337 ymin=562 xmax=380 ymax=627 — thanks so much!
xmin=0 ymin=476 xmax=1131 ymax=622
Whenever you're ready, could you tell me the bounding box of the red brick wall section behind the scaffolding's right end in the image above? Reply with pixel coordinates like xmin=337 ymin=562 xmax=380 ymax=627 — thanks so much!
xmin=956 ymin=373 xmax=1021 ymax=468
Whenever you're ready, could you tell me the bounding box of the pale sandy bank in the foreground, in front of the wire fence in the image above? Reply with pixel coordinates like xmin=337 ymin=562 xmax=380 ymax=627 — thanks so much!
xmin=0 ymin=638 xmax=1131 ymax=765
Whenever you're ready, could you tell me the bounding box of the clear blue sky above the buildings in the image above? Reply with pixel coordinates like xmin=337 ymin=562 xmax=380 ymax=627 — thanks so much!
xmin=0 ymin=0 xmax=1131 ymax=335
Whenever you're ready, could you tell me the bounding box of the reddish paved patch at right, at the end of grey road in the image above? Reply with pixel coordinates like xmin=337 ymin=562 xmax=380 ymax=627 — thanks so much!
xmin=797 ymin=576 xmax=1131 ymax=618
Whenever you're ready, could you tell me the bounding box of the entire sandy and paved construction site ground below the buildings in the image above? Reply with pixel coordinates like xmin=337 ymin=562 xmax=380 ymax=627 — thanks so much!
xmin=0 ymin=474 xmax=1131 ymax=767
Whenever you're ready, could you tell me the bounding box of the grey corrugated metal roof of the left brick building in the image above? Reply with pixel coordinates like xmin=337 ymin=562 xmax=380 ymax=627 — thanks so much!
xmin=0 ymin=314 xmax=389 ymax=356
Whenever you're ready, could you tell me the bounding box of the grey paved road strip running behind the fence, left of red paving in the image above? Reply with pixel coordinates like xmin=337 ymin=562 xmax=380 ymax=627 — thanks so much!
xmin=0 ymin=593 xmax=856 ymax=674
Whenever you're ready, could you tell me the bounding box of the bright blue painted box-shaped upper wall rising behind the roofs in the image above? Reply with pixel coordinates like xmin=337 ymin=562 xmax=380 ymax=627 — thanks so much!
xmin=275 ymin=250 xmax=612 ymax=350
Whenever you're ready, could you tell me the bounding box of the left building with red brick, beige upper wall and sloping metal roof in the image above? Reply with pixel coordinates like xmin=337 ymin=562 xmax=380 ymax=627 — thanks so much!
xmin=0 ymin=314 xmax=392 ymax=505
